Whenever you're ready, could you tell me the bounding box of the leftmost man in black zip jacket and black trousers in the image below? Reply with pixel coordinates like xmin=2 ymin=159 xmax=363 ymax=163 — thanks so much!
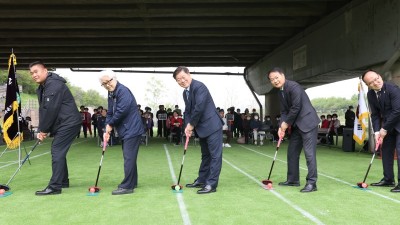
xmin=29 ymin=61 xmax=82 ymax=195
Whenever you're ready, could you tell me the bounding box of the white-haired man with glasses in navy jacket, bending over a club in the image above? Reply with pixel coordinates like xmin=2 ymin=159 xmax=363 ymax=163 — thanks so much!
xmin=100 ymin=71 xmax=146 ymax=195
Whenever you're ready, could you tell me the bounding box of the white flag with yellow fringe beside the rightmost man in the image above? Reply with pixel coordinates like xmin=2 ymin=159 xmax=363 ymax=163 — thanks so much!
xmin=353 ymin=80 xmax=369 ymax=145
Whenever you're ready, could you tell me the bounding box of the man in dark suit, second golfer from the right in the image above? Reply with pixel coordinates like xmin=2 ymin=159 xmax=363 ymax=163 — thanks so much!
xmin=268 ymin=68 xmax=320 ymax=192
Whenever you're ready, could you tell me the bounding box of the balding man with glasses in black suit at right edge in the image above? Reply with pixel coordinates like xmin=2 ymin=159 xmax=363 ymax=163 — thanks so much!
xmin=362 ymin=70 xmax=400 ymax=192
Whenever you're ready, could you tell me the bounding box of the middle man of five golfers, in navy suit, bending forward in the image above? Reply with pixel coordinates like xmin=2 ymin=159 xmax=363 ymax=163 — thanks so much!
xmin=173 ymin=66 xmax=223 ymax=194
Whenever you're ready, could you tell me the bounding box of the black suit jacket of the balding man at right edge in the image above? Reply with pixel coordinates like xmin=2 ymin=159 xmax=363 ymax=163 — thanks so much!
xmin=367 ymin=82 xmax=400 ymax=132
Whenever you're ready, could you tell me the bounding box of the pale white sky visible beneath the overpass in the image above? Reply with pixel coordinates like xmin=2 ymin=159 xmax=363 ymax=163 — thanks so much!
xmin=55 ymin=67 xmax=358 ymax=111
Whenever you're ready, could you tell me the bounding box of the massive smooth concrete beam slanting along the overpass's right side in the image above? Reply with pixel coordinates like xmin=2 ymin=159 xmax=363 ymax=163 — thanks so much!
xmin=245 ymin=0 xmax=400 ymax=115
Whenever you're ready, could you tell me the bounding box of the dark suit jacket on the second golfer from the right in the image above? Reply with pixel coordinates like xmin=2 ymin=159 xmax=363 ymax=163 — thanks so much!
xmin=279 ymin=80 xmax=320 ymax=132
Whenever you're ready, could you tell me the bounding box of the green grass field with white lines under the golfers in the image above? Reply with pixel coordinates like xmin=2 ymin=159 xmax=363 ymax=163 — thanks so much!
xmin=0 ymin=135 xmax=400 ymax=225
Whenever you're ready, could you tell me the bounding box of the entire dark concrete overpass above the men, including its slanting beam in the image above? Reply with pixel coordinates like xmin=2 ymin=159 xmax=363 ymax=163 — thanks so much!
xmin=0 ymin=0 xmax=400 ymax=114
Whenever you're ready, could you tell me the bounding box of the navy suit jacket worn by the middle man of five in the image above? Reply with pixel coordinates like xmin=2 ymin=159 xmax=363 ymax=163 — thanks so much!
xmin=183 ymin=79 xmax=223 ymax=138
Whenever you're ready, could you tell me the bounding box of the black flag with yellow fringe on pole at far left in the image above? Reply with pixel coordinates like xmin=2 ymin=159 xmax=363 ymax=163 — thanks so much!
xmin=3 ymin=54 xmax=23 ymax=149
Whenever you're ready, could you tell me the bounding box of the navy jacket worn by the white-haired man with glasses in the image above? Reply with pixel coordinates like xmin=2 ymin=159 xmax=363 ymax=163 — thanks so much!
xmin=106 ymin=82 xmax=145 ymax=140
